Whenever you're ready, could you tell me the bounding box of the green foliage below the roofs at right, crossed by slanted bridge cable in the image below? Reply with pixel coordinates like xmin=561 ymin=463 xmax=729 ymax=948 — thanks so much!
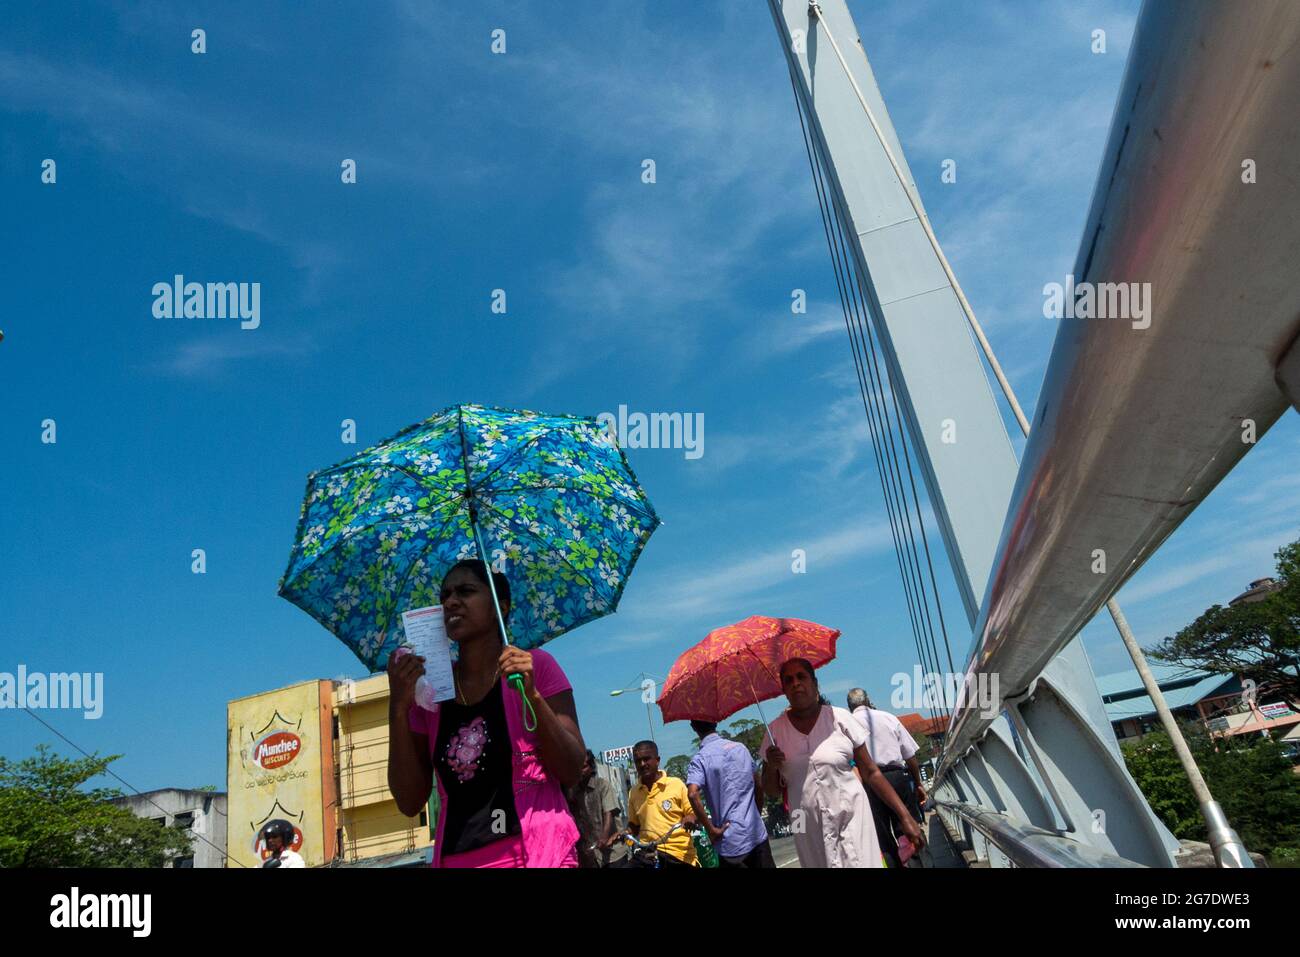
xmin=1122 ymin=722 xmax=1300 ymax=863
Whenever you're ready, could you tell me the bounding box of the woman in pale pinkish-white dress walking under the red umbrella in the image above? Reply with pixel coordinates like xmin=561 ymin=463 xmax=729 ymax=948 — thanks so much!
xmin=763 ymin=658 xmax=926 ymax=867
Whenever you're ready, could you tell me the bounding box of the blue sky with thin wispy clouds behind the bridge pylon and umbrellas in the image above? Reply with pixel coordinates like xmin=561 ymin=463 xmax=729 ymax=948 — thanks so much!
xmin=0 ymin=0 xmax=1300 ymax=789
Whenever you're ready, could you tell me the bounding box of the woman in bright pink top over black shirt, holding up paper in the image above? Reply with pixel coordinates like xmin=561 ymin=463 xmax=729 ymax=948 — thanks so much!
xmin=387 ymin=560 xmax=586 ymax=867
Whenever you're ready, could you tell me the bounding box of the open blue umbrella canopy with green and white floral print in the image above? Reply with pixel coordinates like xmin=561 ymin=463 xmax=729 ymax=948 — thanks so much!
xmin=280 ymin=406 xmax=659 ymax=671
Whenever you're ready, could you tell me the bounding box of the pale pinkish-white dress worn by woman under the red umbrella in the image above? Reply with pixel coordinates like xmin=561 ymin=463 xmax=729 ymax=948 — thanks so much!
xmin=764 ymin=705 xmax=884 ymax=867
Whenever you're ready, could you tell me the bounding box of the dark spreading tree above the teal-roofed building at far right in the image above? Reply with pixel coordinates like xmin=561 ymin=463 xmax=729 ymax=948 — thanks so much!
xmin=1151 ymin=540 xmax=1300 ymax=700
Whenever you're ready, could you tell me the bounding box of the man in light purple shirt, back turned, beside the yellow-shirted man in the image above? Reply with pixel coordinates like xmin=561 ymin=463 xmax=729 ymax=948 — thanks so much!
xmin=686 ymin=722 xmax=776 ymax=867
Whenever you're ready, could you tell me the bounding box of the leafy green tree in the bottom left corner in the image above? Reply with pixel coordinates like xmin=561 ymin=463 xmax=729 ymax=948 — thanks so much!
xmin=0 ymin=745 xmax=190 ymax=867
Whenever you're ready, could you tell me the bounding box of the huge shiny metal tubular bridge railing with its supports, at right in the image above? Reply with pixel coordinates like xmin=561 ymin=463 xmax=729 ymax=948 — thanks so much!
xmin=936 ymin=0 xmax=1300 ymax=863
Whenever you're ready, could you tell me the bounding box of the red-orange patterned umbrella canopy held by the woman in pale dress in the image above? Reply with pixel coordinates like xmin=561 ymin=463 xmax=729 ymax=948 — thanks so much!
xmin=659 ymin=615 xmax=840 ymax=724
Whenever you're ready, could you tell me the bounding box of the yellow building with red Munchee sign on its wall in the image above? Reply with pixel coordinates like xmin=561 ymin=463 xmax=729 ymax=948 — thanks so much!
xmin=226 ymin=675 xmax=437 ymax=867
